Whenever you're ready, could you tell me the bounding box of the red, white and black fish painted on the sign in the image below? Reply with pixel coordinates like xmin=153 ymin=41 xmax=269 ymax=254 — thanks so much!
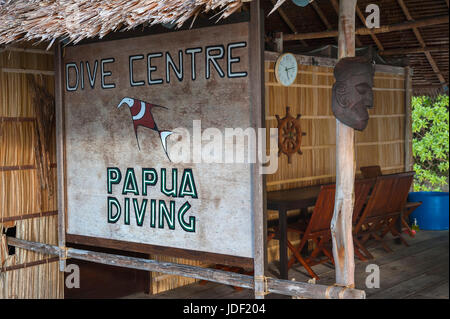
xmin=117 ymin=97 xmax=173 ymax=161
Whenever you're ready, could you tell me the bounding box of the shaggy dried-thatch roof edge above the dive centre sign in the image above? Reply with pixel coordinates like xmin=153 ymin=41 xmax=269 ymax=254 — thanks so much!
xmin=0 ymin=0 xmax=248 ymax=44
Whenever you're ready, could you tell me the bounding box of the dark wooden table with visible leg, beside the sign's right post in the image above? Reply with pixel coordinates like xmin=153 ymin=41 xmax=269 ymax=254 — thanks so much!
xmin=267 ymin=185 xmax=321 ymax=279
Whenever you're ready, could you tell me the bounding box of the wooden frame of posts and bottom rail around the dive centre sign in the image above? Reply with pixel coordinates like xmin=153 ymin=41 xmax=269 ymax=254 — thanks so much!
xmin=55 ymin=13 xmax=266 ymax=276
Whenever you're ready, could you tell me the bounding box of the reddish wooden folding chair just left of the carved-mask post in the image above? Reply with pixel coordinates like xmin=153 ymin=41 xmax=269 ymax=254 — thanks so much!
xmin=287 ymin=184 xmax=336 ymax=280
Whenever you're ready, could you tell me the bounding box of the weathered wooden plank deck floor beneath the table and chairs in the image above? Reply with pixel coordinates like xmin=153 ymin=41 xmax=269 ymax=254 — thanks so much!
xmin=127 ymin=231 xmax=449 ymax=299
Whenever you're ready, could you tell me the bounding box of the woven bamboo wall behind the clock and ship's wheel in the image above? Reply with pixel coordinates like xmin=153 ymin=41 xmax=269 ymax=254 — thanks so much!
xmin=265 ymin=60 xmax=405 ymax=262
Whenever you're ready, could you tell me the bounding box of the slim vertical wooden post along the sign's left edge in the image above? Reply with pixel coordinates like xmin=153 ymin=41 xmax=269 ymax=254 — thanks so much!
xmin=55 ymin=40 xmax=66 ymax=271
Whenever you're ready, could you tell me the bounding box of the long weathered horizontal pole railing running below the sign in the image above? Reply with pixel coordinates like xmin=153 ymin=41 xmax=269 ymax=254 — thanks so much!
xmin=7 ymin=237 xmax=366 ymax=299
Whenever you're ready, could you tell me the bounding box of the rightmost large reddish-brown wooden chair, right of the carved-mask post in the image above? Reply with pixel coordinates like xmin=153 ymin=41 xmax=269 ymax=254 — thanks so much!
xmin=353 ymin=172 xmax=414 ymax=259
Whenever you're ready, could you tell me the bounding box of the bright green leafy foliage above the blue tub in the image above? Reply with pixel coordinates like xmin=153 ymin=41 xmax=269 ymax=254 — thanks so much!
xmin=412 ymin=95 xmax=449 ymax=191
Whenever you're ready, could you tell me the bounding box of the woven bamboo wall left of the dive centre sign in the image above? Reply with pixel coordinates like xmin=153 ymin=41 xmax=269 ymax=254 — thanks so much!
xmin=0 ymin=47 xmax=64 ymax=298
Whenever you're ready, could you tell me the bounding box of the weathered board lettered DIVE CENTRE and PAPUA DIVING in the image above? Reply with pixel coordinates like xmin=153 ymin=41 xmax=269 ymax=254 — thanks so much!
xmin=63 ymin=23 xmax=254 ymax=268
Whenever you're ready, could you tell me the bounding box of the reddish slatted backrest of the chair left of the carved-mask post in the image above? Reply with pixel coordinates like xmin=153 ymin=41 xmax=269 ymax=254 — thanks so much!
xmin=305 ymin=184 xmax=336 ymax=237
